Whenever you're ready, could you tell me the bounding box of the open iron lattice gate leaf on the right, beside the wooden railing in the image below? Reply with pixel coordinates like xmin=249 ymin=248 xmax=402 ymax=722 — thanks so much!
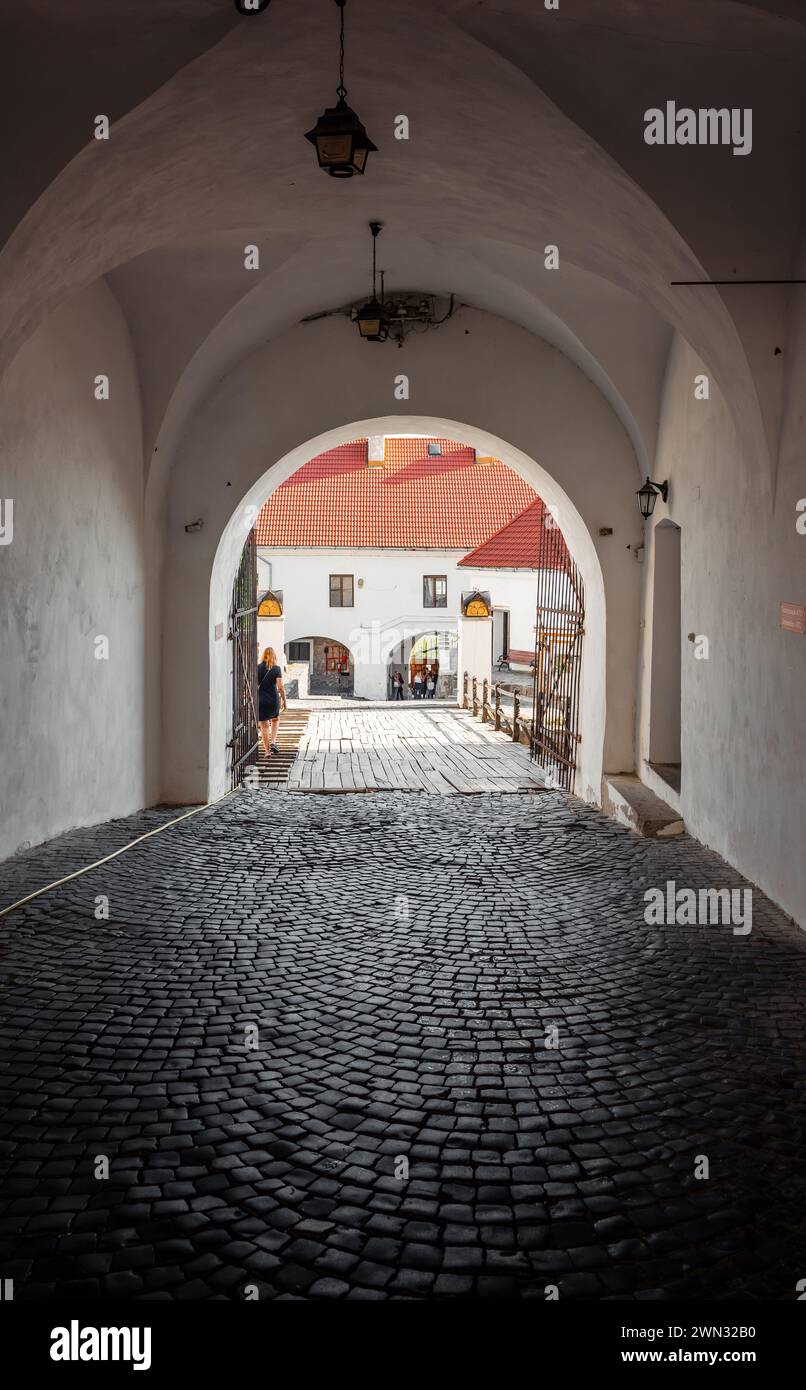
xmin=529 ymin=512 xmax=585 ymax=791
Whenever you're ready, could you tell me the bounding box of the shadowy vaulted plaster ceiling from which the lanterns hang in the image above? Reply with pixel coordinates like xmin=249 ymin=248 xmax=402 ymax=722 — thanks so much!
xmin=0 ymin=0 xmax=806 ymax=492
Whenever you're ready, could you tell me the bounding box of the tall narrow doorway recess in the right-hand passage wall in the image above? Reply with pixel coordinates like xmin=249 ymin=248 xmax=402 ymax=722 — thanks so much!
xmin=649 ymin=521 xmax=682 ymax=791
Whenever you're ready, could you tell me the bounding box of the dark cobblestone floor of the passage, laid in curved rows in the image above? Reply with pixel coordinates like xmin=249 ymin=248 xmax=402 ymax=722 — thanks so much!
xmin=0 ymin=791 xmax=806 ymax=1300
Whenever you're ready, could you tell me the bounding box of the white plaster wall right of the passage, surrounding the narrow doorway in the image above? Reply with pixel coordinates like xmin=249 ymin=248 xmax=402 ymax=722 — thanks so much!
xmin=639 ymin=330 xmax=806 ymax=926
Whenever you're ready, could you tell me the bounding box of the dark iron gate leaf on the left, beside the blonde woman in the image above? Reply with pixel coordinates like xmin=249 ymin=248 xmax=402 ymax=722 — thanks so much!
xmin=227 ymin=531 xmax=258 ymax=787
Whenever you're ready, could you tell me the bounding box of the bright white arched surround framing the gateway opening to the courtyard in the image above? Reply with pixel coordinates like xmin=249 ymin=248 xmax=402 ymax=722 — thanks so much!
xmin=206 ymin=416 xmax=607 ymax=803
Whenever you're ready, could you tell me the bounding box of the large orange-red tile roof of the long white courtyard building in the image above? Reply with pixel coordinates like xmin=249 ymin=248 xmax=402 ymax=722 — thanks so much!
xmin=256 ymin=439 xmax=536 ymax=550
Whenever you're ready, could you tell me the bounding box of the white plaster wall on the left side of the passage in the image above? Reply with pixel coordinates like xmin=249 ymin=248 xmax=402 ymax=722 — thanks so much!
xmin=0 ymin=282 xmax=147 ymax=858
